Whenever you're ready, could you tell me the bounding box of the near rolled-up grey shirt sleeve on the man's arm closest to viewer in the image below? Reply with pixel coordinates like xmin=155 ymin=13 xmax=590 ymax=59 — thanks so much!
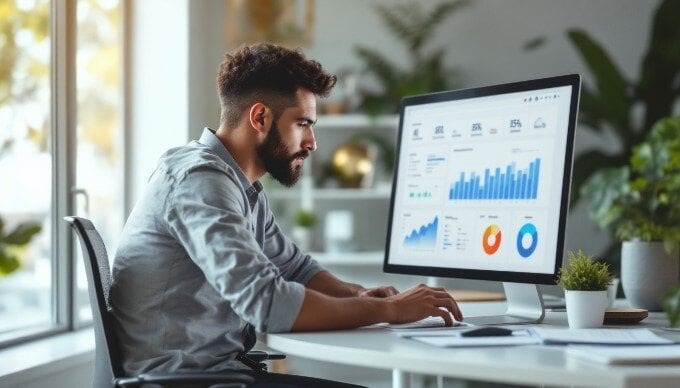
xmin=166 ymin=164 xmax=305 ymax=332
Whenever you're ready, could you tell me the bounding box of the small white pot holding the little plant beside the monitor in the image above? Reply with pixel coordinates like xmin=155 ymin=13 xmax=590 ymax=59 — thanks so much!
xmin=564 ymin=290 xmax=609 ymax=329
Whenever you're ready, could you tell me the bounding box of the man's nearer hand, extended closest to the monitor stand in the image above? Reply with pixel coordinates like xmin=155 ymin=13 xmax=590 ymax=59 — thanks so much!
xmin=387 ymin=284 xmax=463 ymax=326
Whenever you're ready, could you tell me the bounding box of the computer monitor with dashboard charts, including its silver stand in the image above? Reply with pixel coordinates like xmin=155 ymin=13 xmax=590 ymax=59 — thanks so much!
xmin=383 ymin=74 xmax=580 ymax=324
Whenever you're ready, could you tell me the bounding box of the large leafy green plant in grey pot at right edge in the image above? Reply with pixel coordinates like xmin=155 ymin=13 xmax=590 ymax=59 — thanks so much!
xmin=581 ymin=116 xmax=680 ymax=311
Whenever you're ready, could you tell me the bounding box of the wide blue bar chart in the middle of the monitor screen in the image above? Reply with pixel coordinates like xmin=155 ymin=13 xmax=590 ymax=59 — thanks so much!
xmin=449 ymin=158 xmax=541 ymax=201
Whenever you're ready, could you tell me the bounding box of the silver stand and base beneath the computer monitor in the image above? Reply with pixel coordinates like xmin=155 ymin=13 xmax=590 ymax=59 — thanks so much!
xmin=465 ymin=282 xmax=545 ymax=325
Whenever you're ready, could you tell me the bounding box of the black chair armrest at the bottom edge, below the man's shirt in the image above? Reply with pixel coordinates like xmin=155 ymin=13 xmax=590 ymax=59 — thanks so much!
xmin=114 ymin=371 xmax=255 ymax=388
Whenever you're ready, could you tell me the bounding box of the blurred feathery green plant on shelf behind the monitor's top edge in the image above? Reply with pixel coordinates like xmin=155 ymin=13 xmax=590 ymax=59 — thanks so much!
xmin=355 ymin=0 xmax=470 ymax=116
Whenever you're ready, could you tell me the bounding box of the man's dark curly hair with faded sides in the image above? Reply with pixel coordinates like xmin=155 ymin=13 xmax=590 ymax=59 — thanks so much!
xmin=217 ymin=43 xmax=337 ymax=128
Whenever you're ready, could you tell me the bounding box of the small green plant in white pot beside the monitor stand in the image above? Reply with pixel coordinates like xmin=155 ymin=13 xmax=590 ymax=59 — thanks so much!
xmin=557 ymin=250 xmax=612 ymax=329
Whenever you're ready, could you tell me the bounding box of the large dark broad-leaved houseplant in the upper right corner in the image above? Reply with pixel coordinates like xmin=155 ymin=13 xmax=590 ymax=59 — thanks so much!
xmin=564 ymin=0 xmax=680 ymax=208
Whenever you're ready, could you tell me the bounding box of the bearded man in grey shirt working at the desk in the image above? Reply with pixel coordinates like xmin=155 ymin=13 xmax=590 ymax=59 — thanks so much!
xmin=111 ymin=44 xmax=462 ymax=385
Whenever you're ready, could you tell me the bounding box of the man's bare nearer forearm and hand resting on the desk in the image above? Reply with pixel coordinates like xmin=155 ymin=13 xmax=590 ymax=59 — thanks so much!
xmin=292 ymin=284 xmax=463 ymax=331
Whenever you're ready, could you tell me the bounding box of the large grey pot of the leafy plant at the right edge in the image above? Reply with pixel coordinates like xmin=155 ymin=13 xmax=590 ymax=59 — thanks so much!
xmin=621 ymin=241 xmax=680 ymax=311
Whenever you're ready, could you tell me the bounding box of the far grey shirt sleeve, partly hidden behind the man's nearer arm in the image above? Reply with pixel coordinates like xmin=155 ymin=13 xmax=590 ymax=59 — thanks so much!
xmin=264 ymin=199 xmax=324 ymax=284
